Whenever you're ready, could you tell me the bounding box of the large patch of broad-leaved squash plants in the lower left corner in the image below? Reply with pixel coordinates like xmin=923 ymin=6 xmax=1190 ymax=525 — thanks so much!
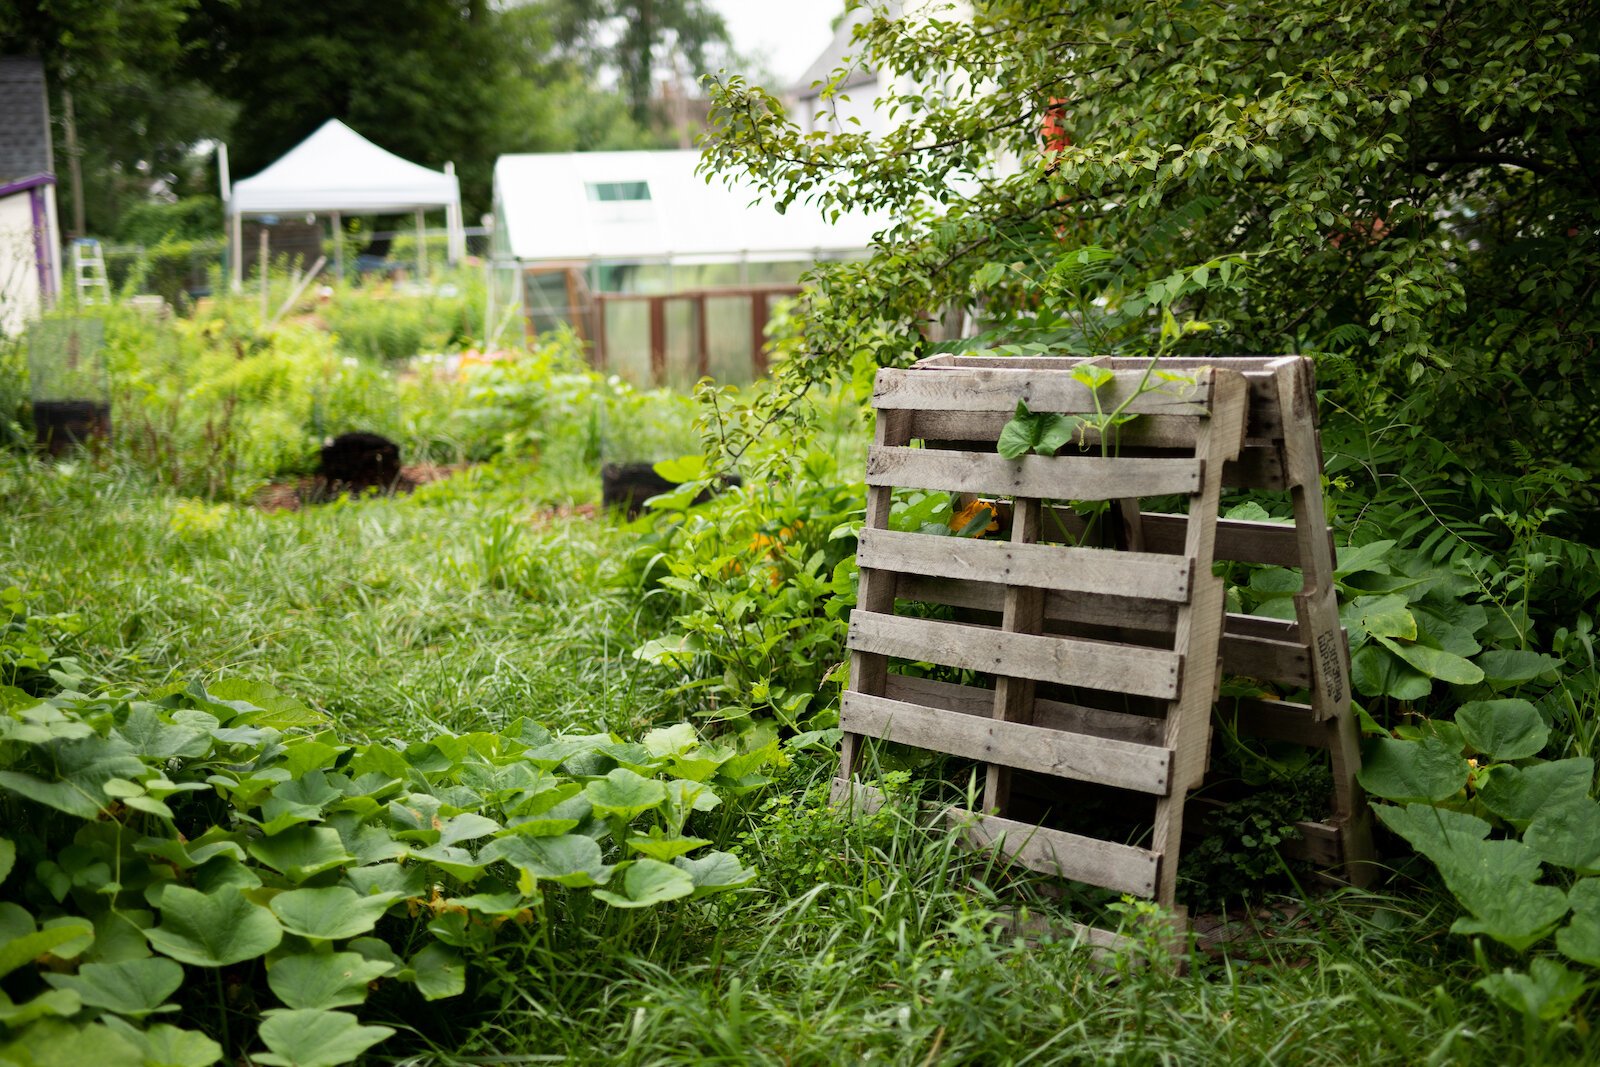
xmin=0 ymin=664 xmax=778 ymax=1067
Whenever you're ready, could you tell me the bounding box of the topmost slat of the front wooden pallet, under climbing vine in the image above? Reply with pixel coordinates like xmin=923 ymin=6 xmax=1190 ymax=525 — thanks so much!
xmin=872 ymin=366 xmax=1211 ymax=414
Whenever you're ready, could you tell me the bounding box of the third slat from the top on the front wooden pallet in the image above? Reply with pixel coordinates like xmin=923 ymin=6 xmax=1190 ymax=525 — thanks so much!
xmin=856 ymin=530 xmax=1194 ymax=603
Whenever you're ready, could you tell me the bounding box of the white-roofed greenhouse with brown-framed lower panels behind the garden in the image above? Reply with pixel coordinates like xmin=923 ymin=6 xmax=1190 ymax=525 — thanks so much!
xmin=490 ymin=150 xmax=885 ymax=382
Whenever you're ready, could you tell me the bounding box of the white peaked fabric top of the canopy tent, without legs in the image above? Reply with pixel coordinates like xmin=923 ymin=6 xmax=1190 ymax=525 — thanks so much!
xmin=229 ymin=118 xmax=461 ymax=214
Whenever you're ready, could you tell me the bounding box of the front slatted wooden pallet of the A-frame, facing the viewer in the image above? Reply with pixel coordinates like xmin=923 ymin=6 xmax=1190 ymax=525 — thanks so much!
xmin=837 ymin=358 xmax=1248 ymax=934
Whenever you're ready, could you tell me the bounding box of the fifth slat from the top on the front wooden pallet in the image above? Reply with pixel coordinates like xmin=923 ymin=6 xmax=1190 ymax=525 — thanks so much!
xmin=840 ymin=693 xmax=1173 ymax=797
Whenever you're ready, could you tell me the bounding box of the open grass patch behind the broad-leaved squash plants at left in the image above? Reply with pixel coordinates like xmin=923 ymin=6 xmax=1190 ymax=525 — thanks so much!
xmin=0 ymin=459 xmax=672 ymax=734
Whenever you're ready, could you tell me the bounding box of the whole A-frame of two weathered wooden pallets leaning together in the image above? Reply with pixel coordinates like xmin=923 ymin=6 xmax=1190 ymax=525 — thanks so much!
xmin=835 ymin=357 xmax=1366 ymax=933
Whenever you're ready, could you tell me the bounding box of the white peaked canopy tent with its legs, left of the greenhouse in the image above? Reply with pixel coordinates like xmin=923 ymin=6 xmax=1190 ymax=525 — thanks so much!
xmin=227 ymin=118 xmax=467 ymax=288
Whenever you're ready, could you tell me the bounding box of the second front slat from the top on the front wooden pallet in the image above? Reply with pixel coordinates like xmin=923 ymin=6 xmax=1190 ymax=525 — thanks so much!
xmin=867 ymin=445 xmax=1203 ymax=501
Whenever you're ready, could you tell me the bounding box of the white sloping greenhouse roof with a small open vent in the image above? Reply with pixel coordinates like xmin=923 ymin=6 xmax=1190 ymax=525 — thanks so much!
xmin=494 ymin=150 xmax=885 ymax=262
